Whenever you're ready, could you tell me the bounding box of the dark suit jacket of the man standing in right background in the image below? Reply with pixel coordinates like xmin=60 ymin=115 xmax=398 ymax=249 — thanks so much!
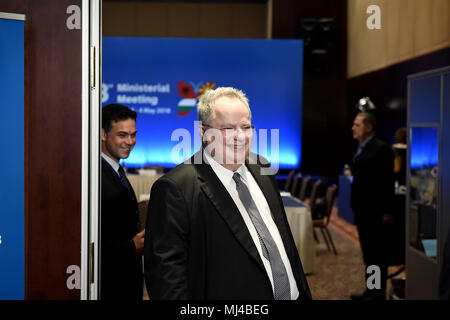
xmin=350 ymin=137 xmax=395 ymax=264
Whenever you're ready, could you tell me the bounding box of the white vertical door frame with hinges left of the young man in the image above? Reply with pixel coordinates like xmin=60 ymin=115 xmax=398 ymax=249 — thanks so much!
xmin=80 ymin=0 xmax=102 ymax=300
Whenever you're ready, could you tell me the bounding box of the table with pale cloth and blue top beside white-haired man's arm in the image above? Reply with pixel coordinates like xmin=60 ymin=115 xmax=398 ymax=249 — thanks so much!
xmin=281 ymin=194 xmax=316 ymax=274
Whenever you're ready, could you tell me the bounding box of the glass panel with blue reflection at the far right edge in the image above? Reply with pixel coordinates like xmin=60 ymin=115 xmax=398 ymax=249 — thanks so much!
xmin=409 ymin=126 xmax=439 ymax=259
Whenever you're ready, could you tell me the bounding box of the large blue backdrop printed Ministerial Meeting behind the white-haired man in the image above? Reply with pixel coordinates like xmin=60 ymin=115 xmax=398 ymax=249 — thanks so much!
xmin=102 ymin=37 xmax=303 ymax=168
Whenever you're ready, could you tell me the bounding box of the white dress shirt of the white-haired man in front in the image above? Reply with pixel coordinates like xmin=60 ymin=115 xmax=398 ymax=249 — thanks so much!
xmin=204 ymin=151 xmax=299 ymax=300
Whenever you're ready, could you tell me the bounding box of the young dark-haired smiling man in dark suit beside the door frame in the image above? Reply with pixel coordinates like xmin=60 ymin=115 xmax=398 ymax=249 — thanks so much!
xmin=100 ymin=104 xmax=145 ymax=300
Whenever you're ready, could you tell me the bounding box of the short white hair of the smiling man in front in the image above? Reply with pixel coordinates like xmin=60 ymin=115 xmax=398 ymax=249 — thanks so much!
xmin=197 ymin=87 xmax=252 ymax=124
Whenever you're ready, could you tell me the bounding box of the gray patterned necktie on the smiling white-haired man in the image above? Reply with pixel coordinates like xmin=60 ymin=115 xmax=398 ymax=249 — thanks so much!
xmin=233 ymin=172 xmax=291 ymax=300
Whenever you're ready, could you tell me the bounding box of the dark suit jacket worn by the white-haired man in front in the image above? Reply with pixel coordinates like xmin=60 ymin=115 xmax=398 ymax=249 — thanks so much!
xmin=145 ymin=154 xmax=311 ymax=300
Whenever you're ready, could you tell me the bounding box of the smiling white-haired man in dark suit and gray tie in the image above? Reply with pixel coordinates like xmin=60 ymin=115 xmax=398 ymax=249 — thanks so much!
xmin=144 ymin=88 xmax=311 ymax=300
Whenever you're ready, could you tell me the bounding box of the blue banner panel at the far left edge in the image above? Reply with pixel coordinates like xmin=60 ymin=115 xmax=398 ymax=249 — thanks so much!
xmin=0 ymin=19 xmax=25 ymax=300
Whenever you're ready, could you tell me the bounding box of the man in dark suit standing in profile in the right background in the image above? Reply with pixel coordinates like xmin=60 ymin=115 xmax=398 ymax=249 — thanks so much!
xmin=350 ymin=112 xmax=394 ymax=300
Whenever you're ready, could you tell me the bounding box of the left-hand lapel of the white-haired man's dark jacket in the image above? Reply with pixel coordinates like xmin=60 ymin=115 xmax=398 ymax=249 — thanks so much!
xmin=195 ymin=159 xmax=265 ymax=272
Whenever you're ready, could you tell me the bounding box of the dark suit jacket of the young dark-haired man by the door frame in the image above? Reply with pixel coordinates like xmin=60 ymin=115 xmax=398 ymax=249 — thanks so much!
xmin=100 ymin=160 xmax=143 ymax=300
